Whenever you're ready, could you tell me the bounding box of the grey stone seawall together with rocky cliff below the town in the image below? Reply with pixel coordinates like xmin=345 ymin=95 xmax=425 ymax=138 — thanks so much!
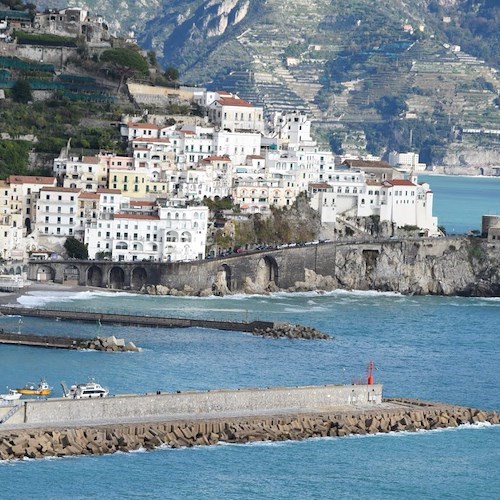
xmin=28 ymin=237 xmax=500 ymax=296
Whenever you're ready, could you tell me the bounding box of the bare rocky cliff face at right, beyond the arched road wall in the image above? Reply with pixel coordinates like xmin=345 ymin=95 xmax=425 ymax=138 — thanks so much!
xmin=322 ymin=238 xmax=500 ymax=296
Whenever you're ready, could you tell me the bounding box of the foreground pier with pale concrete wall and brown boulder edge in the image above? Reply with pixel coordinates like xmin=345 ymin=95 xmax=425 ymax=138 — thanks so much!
xmin=0 ymin=384 xmax=500 ymax=460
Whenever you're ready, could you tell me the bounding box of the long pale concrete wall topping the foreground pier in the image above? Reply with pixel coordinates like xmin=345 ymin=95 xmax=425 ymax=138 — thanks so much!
xmin=15 ymin=384 xmax=382 ymax=425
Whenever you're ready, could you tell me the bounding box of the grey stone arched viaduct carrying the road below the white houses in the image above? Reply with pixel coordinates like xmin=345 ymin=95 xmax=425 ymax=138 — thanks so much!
xmin=28 ymin=242 xmax=394 ymax=292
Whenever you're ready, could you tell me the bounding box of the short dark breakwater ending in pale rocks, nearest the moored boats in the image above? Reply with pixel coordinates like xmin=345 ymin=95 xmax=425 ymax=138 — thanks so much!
xmin=0 ymin=330 xmax=139 ymax=352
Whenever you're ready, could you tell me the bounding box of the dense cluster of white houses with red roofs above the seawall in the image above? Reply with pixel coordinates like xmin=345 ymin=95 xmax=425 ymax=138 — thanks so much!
xmin=0 ymin=89 xmax=438 ymax=262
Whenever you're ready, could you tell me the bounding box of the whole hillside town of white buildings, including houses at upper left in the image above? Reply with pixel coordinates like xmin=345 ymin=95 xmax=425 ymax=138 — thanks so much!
xmin=0 ymin=7 xmax=442 ymax=263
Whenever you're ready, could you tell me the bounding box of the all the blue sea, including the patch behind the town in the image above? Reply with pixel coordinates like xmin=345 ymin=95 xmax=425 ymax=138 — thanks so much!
xmin=0 ymin=176 xmax=500 ymax=500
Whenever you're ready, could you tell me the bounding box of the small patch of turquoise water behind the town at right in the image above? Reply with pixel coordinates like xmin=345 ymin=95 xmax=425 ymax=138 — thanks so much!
xmin=418 ymin=175 xmax=500 ymax=234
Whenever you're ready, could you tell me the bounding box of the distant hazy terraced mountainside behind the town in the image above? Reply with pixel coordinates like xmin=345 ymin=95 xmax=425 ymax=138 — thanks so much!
xmin=27 ymin=0 xmax=500 ymax=161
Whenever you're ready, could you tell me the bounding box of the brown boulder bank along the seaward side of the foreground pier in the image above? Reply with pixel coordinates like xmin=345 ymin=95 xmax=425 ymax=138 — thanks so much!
xmin=0 ymin=400 xmax=500 ymax=460
